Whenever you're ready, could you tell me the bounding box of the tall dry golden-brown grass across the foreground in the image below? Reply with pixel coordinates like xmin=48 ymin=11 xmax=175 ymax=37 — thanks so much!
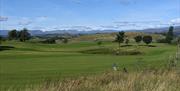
xmin=4 ymin=70 xmax=180 ymax=91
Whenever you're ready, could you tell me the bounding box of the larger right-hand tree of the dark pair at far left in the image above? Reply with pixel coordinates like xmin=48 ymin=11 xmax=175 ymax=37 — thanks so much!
xmin=19 ymin=28 xmax=31 ymax=42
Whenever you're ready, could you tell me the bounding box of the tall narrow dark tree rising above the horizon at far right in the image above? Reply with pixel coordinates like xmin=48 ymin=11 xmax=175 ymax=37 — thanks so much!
xmin=166 ymin=26 xmax=174 ymax=44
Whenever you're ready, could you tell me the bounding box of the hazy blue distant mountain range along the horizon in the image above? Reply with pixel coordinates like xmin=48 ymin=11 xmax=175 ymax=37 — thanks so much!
xmin=0 ymin=26 xmax=180 ymax=36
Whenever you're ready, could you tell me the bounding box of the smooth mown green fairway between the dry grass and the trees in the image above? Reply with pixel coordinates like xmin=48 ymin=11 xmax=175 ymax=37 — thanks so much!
xmin=0 ymin=41 xmax=176 ymax=88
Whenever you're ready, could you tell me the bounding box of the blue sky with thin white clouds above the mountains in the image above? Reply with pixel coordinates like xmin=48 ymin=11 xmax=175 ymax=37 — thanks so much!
xmin=0 ymin=0 xmax=180 ymax=31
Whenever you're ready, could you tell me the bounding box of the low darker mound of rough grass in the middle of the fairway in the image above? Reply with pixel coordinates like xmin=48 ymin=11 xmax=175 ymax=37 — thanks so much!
xmin=80 ymin=48 xmax=142 ymax=55
